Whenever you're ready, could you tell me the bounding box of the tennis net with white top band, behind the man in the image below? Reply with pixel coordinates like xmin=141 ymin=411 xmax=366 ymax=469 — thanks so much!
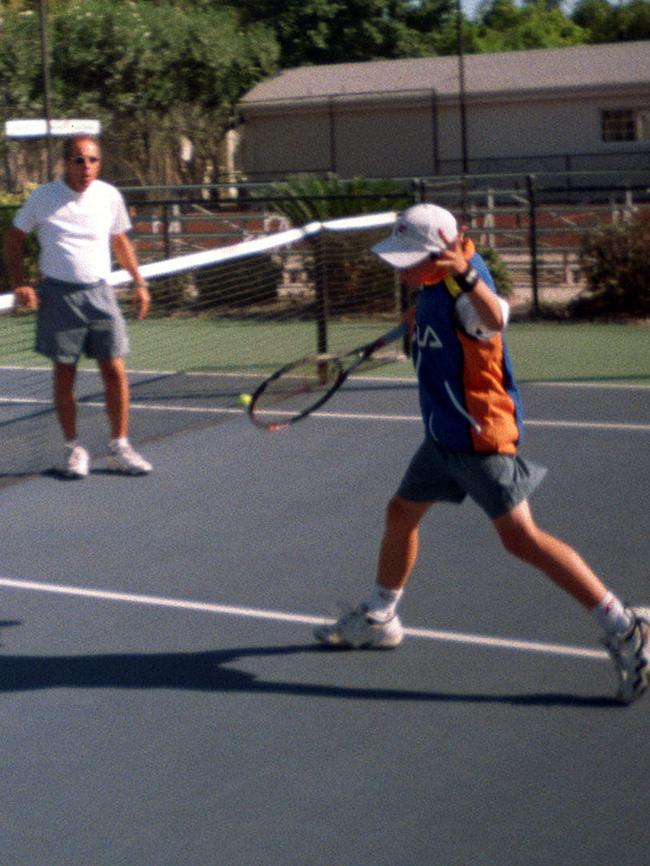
xmin=0 ymin=212 xmax=401 ymax=481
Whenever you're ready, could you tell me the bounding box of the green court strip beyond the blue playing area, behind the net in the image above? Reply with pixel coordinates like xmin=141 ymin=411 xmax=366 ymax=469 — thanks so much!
xmin=0 ymin=318 xmax=650 ymax=383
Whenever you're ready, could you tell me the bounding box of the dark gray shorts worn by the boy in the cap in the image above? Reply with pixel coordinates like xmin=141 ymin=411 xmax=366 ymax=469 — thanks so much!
xmin=397 ymin=437 xmax=546 ymax=520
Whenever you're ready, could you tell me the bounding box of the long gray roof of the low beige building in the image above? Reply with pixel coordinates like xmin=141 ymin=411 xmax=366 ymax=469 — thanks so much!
xmin=240 ymin=41 xmax=650 ymax=108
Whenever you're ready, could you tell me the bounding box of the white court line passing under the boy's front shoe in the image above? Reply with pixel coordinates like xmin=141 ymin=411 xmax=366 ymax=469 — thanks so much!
xmin=0 ymin=577 xmax=609 ymax=661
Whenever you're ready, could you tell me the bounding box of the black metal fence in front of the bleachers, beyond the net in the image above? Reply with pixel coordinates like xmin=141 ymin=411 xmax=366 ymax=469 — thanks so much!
xmin=0 ymin=170 xmax=650 ymax=314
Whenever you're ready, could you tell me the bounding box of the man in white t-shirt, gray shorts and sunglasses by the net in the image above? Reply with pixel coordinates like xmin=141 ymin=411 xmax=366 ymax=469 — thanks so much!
xmin=5 ymin=135 xmax=152 ymax=478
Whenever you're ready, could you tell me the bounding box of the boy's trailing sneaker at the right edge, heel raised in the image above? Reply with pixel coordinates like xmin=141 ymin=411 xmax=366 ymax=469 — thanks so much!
xmin=603 ymin=607 xmax=650 ymax=704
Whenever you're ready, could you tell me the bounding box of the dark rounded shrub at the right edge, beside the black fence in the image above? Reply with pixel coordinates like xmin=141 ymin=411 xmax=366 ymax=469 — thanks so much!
xmin=569 ymin=211 xmax=650 ymax=318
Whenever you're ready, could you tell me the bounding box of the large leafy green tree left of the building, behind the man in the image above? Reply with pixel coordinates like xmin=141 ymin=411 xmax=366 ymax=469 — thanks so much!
xmin=0 ymin=0 xmax=279 ymax=183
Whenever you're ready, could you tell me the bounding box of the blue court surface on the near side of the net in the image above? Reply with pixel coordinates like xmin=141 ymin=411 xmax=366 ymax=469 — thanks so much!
xmin=0 ymin=379 xmax=650 ymax=866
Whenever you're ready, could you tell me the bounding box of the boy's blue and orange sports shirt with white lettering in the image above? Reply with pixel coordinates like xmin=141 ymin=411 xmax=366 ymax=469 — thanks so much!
xmin=412 ymin=253 xmax=523 ymax=454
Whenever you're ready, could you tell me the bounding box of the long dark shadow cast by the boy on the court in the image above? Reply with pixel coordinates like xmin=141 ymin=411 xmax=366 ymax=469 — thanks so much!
xmin=0 ymin=645 xmax=620 ymax=708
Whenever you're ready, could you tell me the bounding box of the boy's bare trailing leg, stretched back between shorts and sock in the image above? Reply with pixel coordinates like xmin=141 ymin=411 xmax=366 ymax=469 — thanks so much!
xmin=494 ymin=501 xmax=607 ymax=610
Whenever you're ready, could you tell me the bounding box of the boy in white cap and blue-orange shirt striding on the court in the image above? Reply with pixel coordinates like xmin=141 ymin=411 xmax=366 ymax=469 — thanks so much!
xmin=314 ymin=204 xmax=650 ymax=703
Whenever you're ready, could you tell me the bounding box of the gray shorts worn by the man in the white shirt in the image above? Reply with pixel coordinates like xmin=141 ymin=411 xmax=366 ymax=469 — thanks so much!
xmin=36 ymin=277 xmax=129 ymax=364
